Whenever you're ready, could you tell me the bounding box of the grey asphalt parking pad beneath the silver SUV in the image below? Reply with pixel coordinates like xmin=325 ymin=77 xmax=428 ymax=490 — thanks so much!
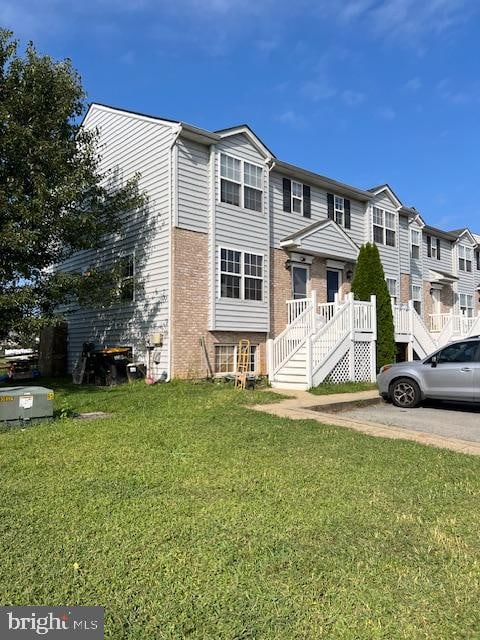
xmin=338 ymin=403 xmax=480 ymax=442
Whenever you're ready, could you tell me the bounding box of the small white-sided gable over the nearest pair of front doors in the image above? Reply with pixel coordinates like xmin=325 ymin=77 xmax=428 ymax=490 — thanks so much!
xmin=280 ymin=219 xmax=359 ymax=262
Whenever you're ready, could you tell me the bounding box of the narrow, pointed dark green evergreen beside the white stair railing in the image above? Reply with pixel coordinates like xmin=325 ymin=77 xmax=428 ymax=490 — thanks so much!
xmin=352 ymin=242 xmax=396 ymax=369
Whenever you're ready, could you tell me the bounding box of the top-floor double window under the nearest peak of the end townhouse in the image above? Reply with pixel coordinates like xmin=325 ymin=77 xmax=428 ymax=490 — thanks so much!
xmin=220 ymin=153 xmax=263 ymax=211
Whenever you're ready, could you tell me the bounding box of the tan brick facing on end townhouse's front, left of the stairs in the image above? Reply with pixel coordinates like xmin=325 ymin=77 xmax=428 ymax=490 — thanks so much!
xmin=170 ymin=229 xmax=268 ymax=378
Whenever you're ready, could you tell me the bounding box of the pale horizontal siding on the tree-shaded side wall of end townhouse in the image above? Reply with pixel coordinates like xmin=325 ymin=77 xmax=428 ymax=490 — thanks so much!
xmin=59 ymin=105 xmax=173 ymax=376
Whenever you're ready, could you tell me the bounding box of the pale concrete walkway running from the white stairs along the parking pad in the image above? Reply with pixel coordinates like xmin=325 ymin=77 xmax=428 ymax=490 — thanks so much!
xmin=251 ymin=389 xmax=480 ymax=455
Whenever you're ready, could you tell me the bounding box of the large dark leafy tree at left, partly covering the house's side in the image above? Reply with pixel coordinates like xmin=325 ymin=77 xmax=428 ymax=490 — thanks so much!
xmin=0 ymin=29 xmax=143 ymax=339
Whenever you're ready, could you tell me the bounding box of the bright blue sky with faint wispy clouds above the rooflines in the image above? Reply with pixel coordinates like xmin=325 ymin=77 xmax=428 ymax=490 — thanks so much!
xmin=0 ymin=0 xmax=480 ymax=232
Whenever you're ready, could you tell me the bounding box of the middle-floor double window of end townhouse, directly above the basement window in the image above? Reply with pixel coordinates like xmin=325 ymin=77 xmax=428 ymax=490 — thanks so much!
xmin=220 ymin=248 xmax=263 ymax=302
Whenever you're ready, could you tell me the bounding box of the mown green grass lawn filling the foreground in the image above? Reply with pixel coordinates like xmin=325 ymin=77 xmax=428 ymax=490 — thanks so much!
xmin=0 ymin=383 xmax=480 ymax=640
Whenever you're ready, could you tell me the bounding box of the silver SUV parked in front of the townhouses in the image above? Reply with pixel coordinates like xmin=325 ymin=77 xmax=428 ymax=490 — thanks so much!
xmin=377 ymin=336 xmax=480 ymax=408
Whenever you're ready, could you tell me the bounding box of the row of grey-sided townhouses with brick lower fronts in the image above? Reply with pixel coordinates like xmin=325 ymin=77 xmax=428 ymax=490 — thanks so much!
xmin=62 ymin=104 xmax=480 ymax=386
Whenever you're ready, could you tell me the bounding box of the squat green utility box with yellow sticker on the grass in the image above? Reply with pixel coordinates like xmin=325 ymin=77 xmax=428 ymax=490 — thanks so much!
xmin=0 ymin=387 xmax=54 ymax=425
